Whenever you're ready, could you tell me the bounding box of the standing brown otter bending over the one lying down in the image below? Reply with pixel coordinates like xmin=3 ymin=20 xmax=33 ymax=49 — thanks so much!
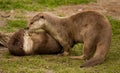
xmin=29 ymin=11 xmax=112 ymax=68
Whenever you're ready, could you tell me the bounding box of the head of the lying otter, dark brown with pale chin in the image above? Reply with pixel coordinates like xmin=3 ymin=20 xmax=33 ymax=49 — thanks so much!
xmin=8 ymin=29 xmax=33 ymax=56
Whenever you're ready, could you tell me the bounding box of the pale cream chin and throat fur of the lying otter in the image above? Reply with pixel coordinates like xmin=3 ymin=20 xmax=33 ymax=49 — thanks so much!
xmin=23 ymin=32 xmax=33 ymax=54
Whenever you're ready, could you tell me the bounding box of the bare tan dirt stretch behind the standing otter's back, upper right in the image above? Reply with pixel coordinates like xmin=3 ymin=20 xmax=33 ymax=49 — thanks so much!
xmin=55 ymin=0 xmax=120 ymax=20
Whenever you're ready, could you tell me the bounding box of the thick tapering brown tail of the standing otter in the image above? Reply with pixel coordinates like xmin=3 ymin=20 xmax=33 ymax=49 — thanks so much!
xmin=80 ymin=43 xmax=109 ymax=68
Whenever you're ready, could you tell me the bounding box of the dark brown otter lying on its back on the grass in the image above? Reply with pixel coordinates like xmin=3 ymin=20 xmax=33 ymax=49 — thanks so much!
xmin=8 ymin=29 xmax=62 ymax=56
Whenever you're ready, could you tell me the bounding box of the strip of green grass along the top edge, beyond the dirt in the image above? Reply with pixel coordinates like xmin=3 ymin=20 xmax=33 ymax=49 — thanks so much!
xmin=0 ymin=0 xmax=96 ymax=11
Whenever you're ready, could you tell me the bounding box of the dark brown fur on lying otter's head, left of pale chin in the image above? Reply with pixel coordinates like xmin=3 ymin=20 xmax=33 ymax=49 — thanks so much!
xmin=8 ymin=30 xmax=25 ymax=56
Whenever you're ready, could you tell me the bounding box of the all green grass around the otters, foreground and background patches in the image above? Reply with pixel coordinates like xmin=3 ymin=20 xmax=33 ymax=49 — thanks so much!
xmin=0 ymin=0 xmax=120 ymax=73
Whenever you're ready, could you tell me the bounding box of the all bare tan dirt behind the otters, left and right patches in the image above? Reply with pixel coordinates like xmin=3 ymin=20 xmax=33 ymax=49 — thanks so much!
xmin=0 ymin=0 xmax=120 ymax=49
